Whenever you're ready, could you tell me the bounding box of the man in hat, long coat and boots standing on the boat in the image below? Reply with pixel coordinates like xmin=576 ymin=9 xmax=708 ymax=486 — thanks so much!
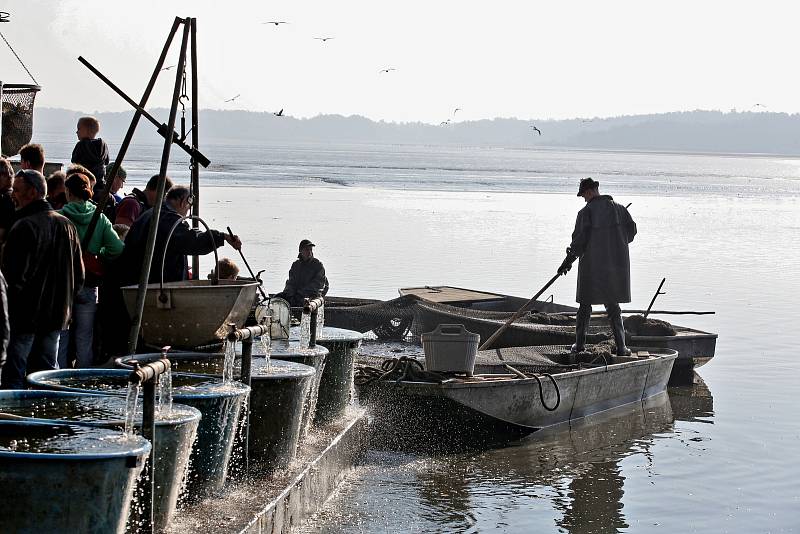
xmin=558 ymin=178 xmax=636 ymax=356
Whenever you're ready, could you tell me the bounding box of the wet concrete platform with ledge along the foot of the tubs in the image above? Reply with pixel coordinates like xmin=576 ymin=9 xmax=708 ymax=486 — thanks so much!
xmin=167 ymin=406 xmax=367 ymax=534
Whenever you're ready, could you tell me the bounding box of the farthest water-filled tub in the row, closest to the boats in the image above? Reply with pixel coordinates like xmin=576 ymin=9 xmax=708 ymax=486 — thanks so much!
xmin=290 ymin=326 xmax=364 ymax=425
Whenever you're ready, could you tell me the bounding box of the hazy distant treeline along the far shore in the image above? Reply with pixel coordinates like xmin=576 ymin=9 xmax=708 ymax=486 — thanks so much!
xmin=34 ymin=108 xmax=800 ymax=155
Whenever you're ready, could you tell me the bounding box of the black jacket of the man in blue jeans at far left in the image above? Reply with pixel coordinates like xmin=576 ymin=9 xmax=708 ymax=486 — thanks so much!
xmin=2 ymin=200 xmax=84 ymax=334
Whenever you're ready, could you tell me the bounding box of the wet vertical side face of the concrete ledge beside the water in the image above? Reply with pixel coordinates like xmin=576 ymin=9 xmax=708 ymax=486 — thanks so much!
xmin=239 ymin=413 xmax=367 ymax=534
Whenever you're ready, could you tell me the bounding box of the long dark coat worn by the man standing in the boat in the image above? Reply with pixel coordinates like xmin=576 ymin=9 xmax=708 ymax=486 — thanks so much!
xmin=570 ymin=195 xmax=636 ymax=304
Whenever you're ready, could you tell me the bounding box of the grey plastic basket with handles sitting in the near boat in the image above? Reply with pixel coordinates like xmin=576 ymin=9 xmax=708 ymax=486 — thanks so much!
xmin=421 ymin=324 xmax=480 ymax=375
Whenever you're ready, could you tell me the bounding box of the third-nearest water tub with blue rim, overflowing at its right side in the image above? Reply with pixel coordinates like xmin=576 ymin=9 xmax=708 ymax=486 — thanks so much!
xmin=28 ymin=369 xmax=250 ymax=500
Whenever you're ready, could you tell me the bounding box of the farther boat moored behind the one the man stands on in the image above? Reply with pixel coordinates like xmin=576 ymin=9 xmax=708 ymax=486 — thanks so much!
xmin=400 ymin=286 xmax=717 ymax=373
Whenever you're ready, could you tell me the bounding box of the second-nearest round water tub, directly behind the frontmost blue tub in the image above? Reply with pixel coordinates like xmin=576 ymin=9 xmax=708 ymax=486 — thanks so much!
xmin=0 ymin=390 xmax=200 ymax=531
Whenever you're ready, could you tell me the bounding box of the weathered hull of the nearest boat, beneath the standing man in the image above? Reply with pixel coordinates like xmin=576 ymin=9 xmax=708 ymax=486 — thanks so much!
xmin=358 ymin=349 xmax=678 ymax=448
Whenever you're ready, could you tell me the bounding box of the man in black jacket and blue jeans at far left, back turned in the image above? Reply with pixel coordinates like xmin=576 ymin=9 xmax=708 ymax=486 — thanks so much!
xmin=0 ymin=170 xmax=84 ymax=389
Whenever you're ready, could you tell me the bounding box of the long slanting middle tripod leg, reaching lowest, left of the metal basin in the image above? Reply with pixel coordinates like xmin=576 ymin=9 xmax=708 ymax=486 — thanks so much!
xmin=128 ymin=20 xmax=189 ymax=354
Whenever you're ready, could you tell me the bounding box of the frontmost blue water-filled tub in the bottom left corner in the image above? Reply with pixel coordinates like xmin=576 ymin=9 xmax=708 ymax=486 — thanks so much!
xmin=0 ymin=421 xmax=150 ymax=534
